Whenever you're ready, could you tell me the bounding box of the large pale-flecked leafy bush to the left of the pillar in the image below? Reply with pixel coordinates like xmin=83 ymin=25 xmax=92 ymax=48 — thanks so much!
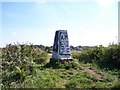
xmin=2 ymin=44 xmax=48 ymax=86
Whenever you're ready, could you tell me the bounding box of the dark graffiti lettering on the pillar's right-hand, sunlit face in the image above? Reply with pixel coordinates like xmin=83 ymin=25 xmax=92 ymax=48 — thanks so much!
xmin=59 ymin=30 xmax=70 ymax=55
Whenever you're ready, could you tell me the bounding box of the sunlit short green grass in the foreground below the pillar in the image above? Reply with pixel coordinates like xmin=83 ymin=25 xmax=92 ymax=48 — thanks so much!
xmin=3 ymin=60 xmax=118 ymax=88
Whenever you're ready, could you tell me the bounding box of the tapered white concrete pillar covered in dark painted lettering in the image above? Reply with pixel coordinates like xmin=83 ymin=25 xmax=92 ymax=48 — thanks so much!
xmin=52 ymin=30 xmax=72 ymax=60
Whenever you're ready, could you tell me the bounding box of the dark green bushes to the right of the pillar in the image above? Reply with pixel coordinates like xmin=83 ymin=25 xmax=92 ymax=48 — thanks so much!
xmin=73 ymin=44 xmax=120 ymax=69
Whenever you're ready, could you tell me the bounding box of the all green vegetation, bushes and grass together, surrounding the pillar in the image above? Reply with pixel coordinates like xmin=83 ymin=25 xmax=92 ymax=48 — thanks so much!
xmin=0 ymin=44 xmax=120 ymax=89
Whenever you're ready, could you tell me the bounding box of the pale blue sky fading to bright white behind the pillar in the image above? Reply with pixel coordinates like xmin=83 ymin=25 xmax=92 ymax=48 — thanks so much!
xmin=0 ymin=0 xmax=119 ymax=46
